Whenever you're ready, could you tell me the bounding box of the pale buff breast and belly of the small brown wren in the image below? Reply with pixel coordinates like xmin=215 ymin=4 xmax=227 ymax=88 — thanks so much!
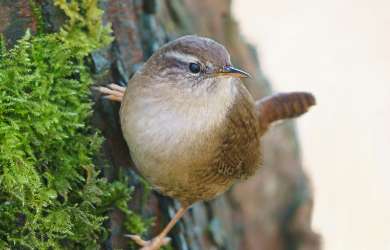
xmin=120 ymin=80 xmax=238 ymax=201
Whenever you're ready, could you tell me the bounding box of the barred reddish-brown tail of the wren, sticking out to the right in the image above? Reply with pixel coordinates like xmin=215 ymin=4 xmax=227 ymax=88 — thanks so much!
xmin=256 ymin=92 xmax=316 ymax=134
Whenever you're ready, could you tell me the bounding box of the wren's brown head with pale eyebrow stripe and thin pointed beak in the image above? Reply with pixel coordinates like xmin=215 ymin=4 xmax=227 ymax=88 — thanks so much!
xmin=144 ymin=35 xmax=250 ymax=90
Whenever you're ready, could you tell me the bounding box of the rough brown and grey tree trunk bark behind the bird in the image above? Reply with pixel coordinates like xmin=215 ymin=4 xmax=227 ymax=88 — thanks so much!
xmin=0 ymin=0 xmax=320 ymax=250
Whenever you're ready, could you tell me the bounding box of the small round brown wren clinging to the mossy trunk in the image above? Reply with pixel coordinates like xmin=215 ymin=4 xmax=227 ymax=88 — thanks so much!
xmin=99 ymin=36 xmax=315 ymax=250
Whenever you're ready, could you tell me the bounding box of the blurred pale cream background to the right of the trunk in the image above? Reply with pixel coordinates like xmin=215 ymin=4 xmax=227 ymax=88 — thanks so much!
xmin=233 ymin=0 xmax=390 ymax=250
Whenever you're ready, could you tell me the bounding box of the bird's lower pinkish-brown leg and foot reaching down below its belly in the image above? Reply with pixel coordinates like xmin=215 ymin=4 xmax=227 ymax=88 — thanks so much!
xmin=128 ymin=206 xmax=189 ymax=250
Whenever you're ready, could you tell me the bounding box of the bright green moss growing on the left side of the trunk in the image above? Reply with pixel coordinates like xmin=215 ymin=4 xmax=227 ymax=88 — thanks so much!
xmin=0 ymin=0 xmax=146 ymax=249
